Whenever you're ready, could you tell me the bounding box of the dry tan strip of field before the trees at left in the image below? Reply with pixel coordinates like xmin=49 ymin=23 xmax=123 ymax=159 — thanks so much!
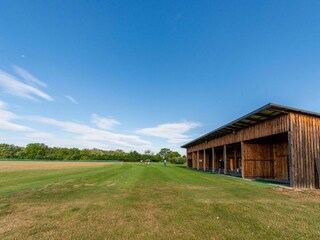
xmin=0 ymin=161 xmax=114 ymax=172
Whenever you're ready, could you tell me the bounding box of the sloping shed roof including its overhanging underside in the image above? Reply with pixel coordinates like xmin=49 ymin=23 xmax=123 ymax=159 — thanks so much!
xmin=181 ymin=103 xmax=320 ymax=148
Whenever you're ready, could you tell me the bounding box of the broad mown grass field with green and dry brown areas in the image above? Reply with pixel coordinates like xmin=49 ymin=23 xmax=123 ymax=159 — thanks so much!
xmin=0 ymin=162 xmax=320 ymax=239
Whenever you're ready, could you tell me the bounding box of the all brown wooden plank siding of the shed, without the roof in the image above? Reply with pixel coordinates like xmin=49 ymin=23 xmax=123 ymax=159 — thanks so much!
xmin=187 ymin=113 xmax=320 ymax=188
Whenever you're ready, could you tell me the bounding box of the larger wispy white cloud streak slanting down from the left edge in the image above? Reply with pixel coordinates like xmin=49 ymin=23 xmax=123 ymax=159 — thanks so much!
xmin=0 ymin=70 xmax=53 ymax=101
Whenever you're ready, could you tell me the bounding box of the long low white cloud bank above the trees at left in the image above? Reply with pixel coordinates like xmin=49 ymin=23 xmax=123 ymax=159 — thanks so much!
xmin=0 ymin=100 xmax=152 ymax=152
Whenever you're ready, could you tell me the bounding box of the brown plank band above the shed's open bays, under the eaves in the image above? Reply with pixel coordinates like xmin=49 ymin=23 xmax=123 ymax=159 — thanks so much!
xmin=187 ymin=114 xmax=289 ymax=152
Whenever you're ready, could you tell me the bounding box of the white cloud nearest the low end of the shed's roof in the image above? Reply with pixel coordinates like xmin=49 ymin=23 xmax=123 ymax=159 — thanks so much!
xmin=136 ymin=122 xmax=201 ymax=144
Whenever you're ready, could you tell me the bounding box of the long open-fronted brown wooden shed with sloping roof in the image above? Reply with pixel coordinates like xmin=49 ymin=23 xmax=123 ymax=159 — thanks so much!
xmin=182 ymin=103 xmax=320 ymax=188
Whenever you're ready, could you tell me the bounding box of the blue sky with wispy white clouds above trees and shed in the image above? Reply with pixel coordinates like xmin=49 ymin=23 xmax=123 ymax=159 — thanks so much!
xmin=0 ymin=0 xmax=320 ymax=152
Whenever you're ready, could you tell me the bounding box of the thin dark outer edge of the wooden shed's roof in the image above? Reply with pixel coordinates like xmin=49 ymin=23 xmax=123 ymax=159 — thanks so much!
xmin=181 ymin=103 xmax=320 ymax=148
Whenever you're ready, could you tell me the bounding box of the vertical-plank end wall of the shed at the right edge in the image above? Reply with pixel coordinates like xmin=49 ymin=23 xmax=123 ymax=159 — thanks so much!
xmin=290 ymin=113 xmax=320 ymax=188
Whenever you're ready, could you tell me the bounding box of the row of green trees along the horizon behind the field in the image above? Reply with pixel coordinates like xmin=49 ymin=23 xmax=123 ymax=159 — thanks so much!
xmin=0 ymin=143 xmax=186 ymax=164
